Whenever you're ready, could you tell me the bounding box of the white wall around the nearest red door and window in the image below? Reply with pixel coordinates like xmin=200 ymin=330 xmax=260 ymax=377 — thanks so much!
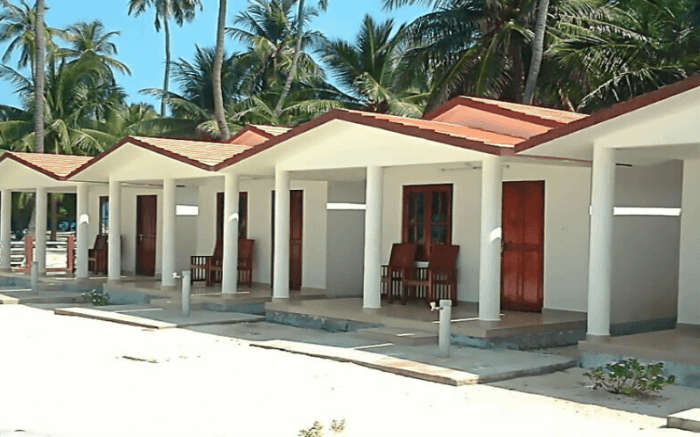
xmin=382 ymin=163 xmax=590 ymax=311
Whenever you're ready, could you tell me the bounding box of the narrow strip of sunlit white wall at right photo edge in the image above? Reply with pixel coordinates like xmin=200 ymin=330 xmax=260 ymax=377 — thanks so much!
xmin=678 ymin=160 xmax=700 ymax=325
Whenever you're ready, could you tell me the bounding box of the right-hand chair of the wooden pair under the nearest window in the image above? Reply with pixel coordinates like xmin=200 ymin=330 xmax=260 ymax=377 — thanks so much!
xmin=401 ymin=244 xmax=459 ymax=306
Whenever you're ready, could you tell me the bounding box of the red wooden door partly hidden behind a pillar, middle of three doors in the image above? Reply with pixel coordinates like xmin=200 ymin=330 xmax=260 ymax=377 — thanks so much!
xmin=270 ymin=190 xmax=304 ymax=290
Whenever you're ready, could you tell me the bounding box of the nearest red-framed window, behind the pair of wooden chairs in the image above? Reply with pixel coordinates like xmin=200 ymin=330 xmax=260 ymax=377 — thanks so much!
xmin=403 ymin=185 xmax=452 ymax=260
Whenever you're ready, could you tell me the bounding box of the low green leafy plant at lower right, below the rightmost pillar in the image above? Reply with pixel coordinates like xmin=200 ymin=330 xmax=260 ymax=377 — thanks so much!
xmin=583 ymin=358 xmax=676 ymax=396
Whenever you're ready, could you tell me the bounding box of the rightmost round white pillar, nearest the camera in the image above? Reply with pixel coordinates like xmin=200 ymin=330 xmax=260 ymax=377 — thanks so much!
xmin=588 ymin=146 xmax=615 ymax=336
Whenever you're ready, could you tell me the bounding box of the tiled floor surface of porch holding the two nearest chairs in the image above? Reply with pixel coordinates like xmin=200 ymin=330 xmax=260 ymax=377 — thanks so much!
xmin=265 ymin=298 xmax=586 ymax=344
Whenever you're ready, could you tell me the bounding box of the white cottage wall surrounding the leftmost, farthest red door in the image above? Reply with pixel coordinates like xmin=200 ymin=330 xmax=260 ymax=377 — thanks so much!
xmin=88 ymin=185 xmax=197 ymax=275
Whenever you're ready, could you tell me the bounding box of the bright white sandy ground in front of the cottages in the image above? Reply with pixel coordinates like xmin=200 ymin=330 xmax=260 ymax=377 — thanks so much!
xmin=0 ymin=305 xmax=700 ymax=437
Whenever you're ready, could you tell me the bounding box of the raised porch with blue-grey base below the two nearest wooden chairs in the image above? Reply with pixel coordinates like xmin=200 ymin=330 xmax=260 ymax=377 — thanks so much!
xmin=265 ymin=298 xmax=586 ymax=349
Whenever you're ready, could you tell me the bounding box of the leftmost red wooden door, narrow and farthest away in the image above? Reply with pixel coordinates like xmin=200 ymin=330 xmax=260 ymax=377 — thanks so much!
xmin=136 ymin=196 xmax=158 ymax=276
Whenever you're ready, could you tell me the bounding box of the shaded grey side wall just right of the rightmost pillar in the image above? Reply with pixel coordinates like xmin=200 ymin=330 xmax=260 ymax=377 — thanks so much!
xmin=611 ymin=161 xmax=683 ymax=323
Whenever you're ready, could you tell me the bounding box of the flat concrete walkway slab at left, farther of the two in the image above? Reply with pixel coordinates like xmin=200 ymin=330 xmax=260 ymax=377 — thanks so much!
xmin=54 ymin=305 xmax=264 ymax=329
